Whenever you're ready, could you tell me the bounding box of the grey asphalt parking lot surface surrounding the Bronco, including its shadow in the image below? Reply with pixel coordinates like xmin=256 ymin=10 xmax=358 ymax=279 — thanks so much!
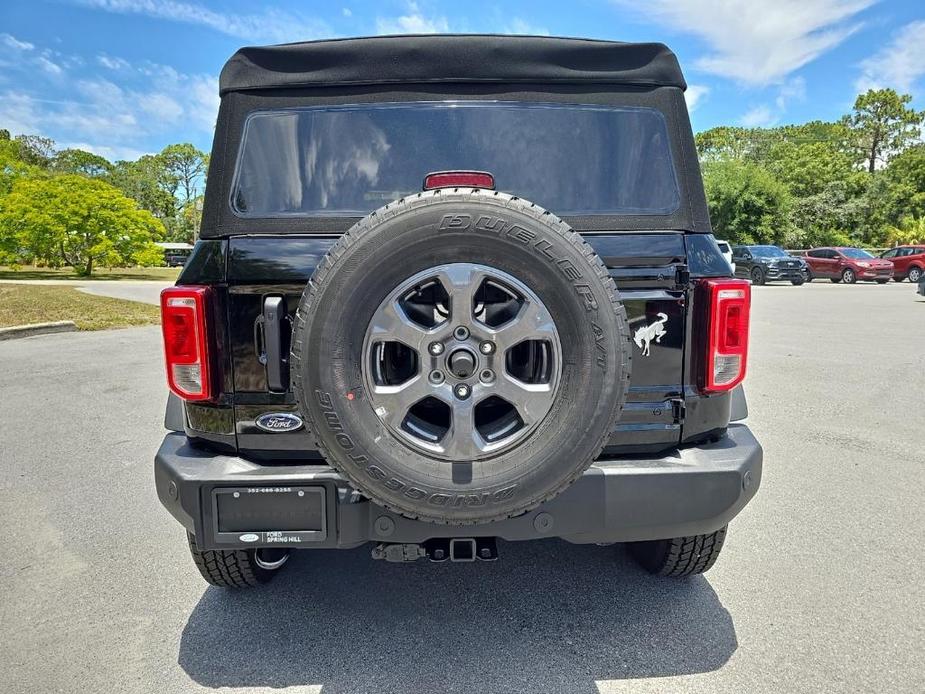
xmin=0 ymin=282 xmax=925 ymax=694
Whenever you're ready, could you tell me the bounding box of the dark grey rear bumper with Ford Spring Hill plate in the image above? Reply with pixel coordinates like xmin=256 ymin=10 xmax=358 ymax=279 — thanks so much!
xmin=154 ymin=424 xmax=762 ymax=549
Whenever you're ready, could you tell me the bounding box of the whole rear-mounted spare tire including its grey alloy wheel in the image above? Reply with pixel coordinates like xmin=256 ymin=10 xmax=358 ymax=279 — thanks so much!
xmin=291 ymin=188 xmax=630 ymax=525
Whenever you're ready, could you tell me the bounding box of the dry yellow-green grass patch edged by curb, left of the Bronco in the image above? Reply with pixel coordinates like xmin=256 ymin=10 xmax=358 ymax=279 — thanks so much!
xmin=0 ymin=284 xmax=161 ymax=330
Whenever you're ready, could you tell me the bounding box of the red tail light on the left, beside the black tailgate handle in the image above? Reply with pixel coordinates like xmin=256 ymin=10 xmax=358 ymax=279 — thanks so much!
xmin=161 ymin=287 xmax=213 ymax=400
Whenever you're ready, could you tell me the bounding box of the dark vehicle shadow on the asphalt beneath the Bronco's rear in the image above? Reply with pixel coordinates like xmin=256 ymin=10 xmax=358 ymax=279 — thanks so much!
xmin=179 ymin=540 xmax=737 ymax=694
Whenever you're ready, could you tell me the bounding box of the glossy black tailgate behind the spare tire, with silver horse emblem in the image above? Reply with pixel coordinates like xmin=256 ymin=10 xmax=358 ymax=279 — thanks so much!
xmin=226 ymin=233 xmax=687 ymax=458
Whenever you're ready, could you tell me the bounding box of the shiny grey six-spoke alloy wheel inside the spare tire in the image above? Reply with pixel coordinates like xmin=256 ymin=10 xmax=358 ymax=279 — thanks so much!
xmin=363 ymin=263 xmax=562 ymax=462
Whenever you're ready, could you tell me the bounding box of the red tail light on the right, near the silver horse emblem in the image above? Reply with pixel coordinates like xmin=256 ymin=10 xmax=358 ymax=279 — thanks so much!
xmin=701 ymin=279 xmax=752 ymax=393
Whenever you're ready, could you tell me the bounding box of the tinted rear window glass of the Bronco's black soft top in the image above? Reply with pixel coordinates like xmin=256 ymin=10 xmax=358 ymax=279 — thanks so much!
xmin=231 ymin=101 xmax=680 ymax=217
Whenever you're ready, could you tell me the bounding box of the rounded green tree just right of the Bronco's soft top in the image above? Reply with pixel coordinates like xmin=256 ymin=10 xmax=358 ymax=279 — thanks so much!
xmin=703 ymin=161 xmax=793 ymax=244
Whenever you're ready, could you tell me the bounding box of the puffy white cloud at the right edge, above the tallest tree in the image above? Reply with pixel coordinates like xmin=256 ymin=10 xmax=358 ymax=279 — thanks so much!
xmin=855 ymin=20 xmax=925 ymax=92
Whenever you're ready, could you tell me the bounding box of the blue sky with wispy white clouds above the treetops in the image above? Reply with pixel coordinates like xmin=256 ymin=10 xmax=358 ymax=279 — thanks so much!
xmin=0 ymin=0 xmax=925 ymax=159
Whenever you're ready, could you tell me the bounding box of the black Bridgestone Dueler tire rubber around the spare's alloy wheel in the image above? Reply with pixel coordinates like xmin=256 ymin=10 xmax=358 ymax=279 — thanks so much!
xmin=291 ymin=188 xmax=631 ymax=525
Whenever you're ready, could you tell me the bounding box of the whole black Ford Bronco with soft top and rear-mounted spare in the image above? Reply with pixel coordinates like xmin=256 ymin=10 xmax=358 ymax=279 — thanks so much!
xmin=155 ymin=36 xmax=762 ymax=587
